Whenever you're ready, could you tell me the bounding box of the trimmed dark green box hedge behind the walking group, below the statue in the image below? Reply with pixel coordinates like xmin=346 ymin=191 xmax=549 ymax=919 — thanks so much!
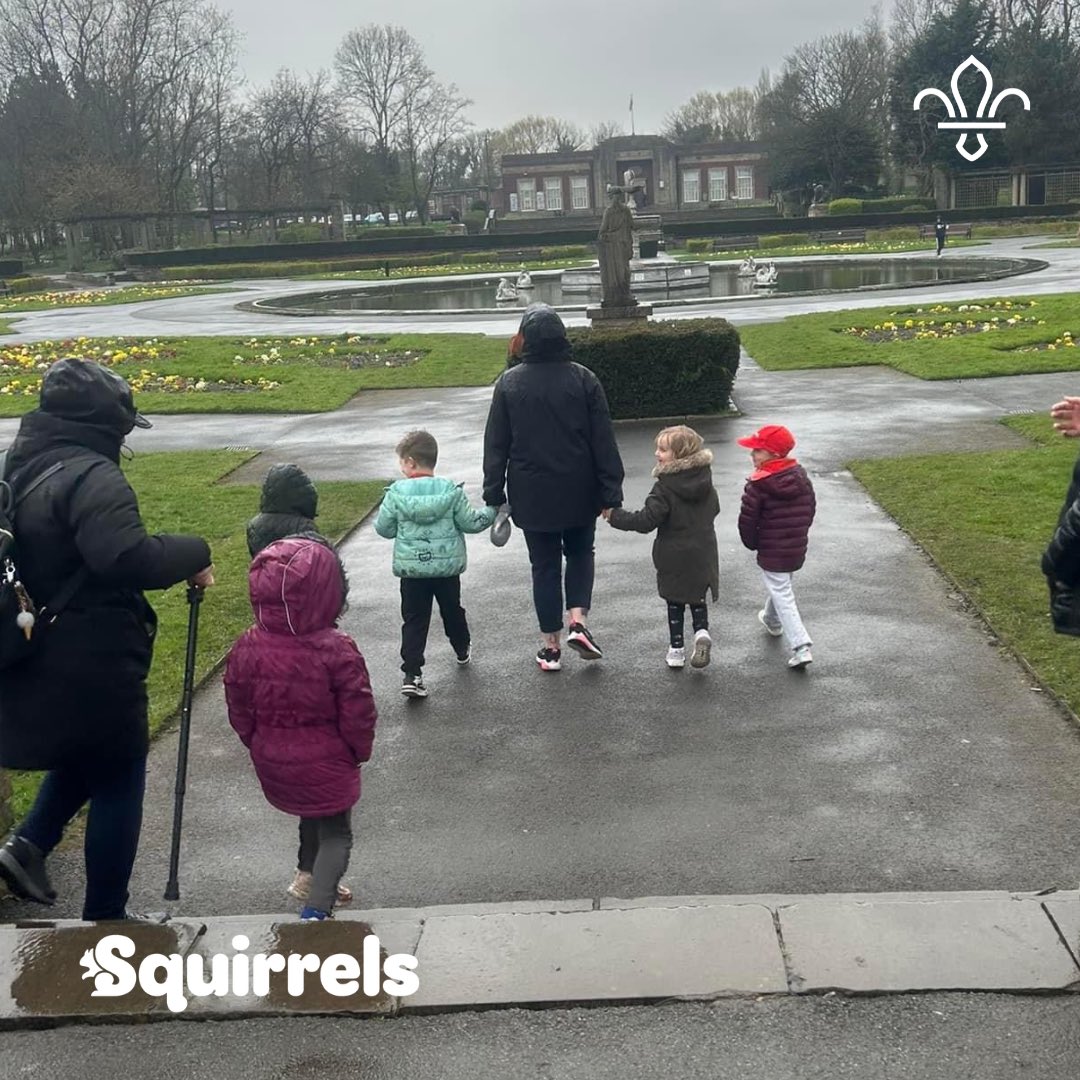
xmin=548 ymin=319 xmax=739 ymax=420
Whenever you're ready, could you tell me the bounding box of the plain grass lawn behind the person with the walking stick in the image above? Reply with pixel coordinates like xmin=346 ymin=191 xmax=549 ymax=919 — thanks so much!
xmin=3 ymin=450 xmax=384 ymax=818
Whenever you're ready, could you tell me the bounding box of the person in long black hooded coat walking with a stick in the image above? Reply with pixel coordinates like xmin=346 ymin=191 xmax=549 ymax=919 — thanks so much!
xmin=0 ymin=360 xmax=214 ymax=919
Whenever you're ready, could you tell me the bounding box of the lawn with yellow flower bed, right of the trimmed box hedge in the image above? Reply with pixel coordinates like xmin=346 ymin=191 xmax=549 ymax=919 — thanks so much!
xmin=739 ymin=294 xmax=1080 ymax=379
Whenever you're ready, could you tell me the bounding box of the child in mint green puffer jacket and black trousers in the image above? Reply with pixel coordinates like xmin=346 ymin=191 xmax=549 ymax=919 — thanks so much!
xmin=375 ymin=431 xmax=496 ymax=698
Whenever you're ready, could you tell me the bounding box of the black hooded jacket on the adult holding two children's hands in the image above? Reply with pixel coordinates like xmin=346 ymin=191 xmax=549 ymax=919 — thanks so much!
xmin=484 ymin=305 xmax=623 ymax=532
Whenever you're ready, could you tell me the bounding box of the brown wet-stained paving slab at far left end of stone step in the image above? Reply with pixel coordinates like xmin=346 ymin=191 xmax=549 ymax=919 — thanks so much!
xmin=0 ymin=920 xmax=204 ymax=1028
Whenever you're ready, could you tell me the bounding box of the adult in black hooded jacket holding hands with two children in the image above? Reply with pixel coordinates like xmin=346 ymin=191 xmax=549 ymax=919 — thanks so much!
xmin=484 ymin=303 xmax=623 ymax=671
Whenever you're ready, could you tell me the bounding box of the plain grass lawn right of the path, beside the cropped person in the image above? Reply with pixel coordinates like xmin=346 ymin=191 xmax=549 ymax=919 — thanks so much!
xmin=852 ymin=416 xmax=1080 ymax=712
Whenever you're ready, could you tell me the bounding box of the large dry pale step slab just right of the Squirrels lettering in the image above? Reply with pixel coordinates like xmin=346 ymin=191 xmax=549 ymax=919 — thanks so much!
xmin=402 ymin=906 xmax=787 ymax=1010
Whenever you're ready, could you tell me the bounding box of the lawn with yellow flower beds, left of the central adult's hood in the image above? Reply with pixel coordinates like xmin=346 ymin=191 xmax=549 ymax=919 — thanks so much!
xmin=0 ymin=334 xmax=507 ymax=416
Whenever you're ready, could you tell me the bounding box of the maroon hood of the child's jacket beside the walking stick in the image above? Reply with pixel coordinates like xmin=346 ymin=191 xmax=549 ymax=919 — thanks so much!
xmin=247 ymin=539 xmax=345 ymax=637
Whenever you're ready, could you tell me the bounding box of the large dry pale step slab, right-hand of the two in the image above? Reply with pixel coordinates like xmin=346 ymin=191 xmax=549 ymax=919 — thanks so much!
xmin=779 ymin=900 xmax=1080 ymax=993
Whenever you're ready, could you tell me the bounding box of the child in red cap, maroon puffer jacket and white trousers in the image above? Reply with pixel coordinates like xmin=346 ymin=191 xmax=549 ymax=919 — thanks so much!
xmin=738 ymin=424 xmax=816 ymax=669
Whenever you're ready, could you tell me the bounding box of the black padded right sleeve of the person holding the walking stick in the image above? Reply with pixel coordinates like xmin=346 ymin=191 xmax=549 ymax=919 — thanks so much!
xmin=68 ymin=461 xmax=211 ymax=589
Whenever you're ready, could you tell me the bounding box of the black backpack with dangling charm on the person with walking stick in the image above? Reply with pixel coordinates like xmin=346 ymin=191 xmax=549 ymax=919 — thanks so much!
xmin=0 ymin=450 xmax=90 ymax=671
